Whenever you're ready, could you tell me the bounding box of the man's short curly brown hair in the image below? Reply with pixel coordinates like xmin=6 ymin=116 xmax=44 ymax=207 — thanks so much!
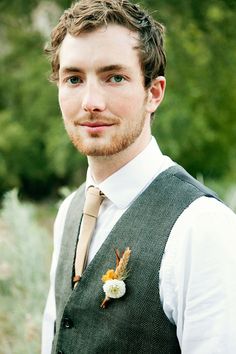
xmin=45 ymin=0 xmax=166 ymax=88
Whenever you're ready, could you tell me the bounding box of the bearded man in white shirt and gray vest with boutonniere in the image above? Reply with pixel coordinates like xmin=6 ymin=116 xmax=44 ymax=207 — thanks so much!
xmin=42 ymin=0 xmax=236 ymax=354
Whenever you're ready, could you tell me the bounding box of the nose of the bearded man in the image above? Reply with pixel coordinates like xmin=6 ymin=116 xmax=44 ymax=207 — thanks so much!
xmin=82 ymin=82 xmax=106 ymax=113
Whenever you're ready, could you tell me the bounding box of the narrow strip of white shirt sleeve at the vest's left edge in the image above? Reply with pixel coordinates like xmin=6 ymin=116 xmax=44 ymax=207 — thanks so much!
xmin=41 ymin=193 xmax=74 ymax=354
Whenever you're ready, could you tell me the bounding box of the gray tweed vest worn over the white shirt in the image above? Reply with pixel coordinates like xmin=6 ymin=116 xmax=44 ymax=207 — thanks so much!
xmin=52 ymin=166 xmax=218 ymax=354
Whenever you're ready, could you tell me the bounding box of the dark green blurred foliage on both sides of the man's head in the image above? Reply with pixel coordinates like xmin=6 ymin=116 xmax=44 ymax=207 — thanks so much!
xmin=0 ymin=0 xmax=236 ymax=198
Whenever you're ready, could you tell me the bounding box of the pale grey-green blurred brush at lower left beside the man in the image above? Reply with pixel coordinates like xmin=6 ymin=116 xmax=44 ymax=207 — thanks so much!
xmin=0 ymin=190 xmax=52 ymax=354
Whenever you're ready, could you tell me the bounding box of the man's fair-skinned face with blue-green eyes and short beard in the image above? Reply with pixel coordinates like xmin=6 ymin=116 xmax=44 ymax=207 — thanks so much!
xmin=58 ymin=25 xmax=155 ymax=156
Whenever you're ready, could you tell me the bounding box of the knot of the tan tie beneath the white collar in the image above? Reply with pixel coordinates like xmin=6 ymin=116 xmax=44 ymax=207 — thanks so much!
xmin=84 ymin=186 xmax=105 ymax=218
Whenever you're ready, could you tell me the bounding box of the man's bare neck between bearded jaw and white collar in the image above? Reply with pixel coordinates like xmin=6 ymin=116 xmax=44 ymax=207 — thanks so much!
xmin=88 ymin=135 xmax=151 ymax=183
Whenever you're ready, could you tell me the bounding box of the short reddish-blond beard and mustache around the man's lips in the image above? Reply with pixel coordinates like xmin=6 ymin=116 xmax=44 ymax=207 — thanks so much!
xmin=64 ymin=112 xmax=146 ymax=156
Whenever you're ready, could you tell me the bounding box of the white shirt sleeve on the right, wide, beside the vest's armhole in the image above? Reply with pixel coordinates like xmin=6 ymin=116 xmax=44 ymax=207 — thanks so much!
xmin=160 ymin=197 xmax=236 ymax=354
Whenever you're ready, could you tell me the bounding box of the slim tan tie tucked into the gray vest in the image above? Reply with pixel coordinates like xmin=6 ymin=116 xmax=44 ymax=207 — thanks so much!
xmin=73 ymin=186 xmax=105 ymax=285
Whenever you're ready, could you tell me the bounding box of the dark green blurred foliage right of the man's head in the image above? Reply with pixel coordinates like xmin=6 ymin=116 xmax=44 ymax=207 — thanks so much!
xmin=155 ymin=1 xmax=236 ymax=179
